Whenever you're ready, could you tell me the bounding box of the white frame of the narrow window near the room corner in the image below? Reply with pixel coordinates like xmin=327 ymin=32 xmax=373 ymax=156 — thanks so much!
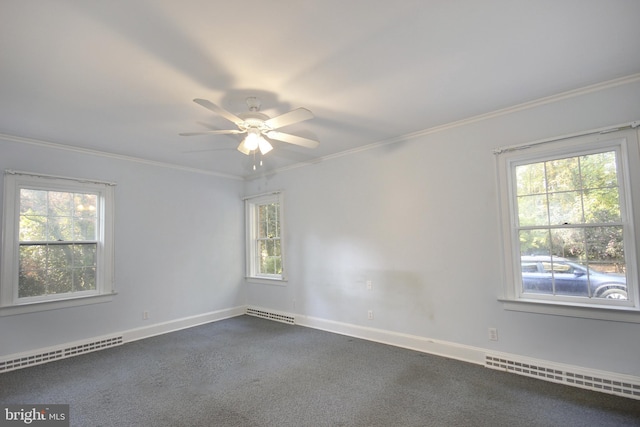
xmin=244 ymin=191 xmax=286 ymax=284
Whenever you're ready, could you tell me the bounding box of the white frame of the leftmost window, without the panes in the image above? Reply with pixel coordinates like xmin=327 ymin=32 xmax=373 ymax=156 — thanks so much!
xmin=0 ymin=170 xmax=115 ymax=316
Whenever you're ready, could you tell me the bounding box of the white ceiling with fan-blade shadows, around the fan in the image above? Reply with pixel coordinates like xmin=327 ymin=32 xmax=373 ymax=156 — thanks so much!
xmin=0 ymin=0 xmax=640 ymax=176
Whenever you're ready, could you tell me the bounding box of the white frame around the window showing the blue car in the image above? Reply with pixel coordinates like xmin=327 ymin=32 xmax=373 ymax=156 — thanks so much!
xmin=495 ymin=126 xmax=640 ymax=323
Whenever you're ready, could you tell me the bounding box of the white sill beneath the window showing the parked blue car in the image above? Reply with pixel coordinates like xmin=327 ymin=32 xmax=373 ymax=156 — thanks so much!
xmin=498 ymin=299 xmax=640 ymax=323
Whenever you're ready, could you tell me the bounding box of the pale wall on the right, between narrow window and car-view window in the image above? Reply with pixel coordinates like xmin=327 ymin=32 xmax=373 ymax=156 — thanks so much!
xmin=245 ymin=79 xmax=640 ymax=376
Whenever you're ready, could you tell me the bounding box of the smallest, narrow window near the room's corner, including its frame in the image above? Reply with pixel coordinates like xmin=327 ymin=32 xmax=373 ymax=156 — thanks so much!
xmin=245 ymin=193 xmax=284 ymax=280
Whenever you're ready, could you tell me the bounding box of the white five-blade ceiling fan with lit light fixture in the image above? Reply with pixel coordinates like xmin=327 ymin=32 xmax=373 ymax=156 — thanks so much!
xmin=180 ymin=97 xmax=320 ymax=155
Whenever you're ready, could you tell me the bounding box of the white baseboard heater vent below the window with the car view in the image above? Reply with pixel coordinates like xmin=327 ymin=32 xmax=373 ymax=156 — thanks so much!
xmin=485 ymin=355 xmax=640 ymax=400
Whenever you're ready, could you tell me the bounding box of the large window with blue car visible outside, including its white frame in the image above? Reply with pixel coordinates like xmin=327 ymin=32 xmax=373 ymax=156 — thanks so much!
xmin=498 ymin=130 xmax=640 ymax=318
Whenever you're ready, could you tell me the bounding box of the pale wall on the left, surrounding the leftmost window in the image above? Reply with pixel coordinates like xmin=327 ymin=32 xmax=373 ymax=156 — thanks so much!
xmin=0 ymin=138 xmax=245 ymax=356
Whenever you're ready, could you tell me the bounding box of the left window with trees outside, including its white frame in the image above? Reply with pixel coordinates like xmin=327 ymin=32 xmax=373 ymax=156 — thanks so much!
xmin=0 ymin=171 xmax=113 ymax=314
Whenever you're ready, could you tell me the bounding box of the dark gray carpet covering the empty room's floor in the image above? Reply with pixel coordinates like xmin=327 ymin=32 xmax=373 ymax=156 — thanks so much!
xmin=0 ymin=316 xmax=640 ymax=427
